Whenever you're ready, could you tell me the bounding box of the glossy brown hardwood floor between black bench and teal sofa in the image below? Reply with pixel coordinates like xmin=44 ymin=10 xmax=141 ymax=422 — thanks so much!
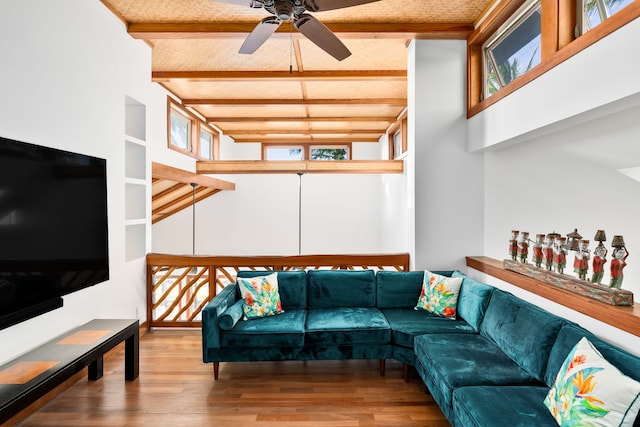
xmin=19 ymin=330 xmax=449 ymax=427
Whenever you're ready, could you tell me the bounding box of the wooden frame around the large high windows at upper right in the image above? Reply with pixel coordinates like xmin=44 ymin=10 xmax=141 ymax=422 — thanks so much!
xmin=467 ymin=0 xmax=640 ymax=118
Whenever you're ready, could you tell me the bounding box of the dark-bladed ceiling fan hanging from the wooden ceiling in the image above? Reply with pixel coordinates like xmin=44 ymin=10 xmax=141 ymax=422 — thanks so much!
xmin=215 ymin=0 xmax=380 ymax=61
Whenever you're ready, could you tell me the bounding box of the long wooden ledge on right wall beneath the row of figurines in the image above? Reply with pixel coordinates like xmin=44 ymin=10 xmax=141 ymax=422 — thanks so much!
xmin=467 ymin=256 xmax=640 ymax=336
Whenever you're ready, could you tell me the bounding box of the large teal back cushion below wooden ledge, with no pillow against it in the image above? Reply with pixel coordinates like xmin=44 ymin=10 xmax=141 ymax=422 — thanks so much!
xmin=480 ymin=289 xmax=564 ymax=381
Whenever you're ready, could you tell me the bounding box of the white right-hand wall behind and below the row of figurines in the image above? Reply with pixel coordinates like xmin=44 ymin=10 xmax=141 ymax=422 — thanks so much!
xmin=468 ymin=15 xmax=640 ymax=354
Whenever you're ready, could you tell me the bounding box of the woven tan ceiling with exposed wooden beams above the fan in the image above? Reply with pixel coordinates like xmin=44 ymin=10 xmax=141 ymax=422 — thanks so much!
xmin=102 ymin=0 xmax=493 ymax=144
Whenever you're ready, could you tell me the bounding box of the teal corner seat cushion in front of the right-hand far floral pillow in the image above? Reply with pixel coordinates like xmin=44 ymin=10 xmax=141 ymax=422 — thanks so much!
xmin=382 ymin=308 xmax=477 ymax=349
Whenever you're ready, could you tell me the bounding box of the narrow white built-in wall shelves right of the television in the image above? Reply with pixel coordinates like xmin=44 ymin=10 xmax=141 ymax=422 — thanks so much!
xmin=124 ymin=96 xmax=148 ymax=261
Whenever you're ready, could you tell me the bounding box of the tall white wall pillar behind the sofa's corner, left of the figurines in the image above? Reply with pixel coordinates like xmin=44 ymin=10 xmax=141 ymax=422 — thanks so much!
xmin=409 ymin=40 xmax=484 ymax=270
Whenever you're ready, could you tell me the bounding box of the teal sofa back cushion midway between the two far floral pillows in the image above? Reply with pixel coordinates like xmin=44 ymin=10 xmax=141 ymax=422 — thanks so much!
xmin=307 ymin=270 xmax=376 ymax=308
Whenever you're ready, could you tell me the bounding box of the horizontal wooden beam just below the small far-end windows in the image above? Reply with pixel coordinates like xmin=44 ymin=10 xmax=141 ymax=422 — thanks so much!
xmin=196 ymin=160 xmax=404 ymax=174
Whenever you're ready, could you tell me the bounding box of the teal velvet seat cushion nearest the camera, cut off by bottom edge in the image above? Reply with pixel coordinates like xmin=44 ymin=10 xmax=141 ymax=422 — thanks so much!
xmin=453 ymin=386 xmax=558 ymax=427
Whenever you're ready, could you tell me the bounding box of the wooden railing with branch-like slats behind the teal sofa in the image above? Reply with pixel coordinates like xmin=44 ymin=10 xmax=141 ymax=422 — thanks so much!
xmin=147 ymin=254 xmax=409 ymax=328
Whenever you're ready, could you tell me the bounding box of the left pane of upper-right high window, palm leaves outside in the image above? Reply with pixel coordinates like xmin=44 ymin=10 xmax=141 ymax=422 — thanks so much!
xmin=483 ymin=0 xmax=541 ymax=98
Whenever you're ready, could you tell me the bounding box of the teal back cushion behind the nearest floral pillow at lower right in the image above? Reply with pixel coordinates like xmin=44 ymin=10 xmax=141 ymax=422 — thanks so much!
xmin=544 ymin=321 xmax=640 ymax=386
